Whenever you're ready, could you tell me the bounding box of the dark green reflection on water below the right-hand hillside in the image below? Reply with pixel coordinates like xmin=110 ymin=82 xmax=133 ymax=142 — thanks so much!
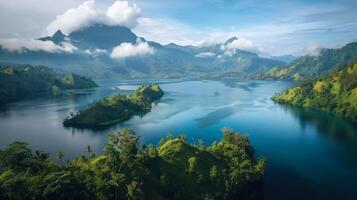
xmin=281 ymin=105 xmax=357 ymax=168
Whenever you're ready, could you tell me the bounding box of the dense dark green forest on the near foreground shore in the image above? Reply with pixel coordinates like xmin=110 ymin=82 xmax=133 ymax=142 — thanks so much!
xmin=0 ymin=129 xmax=265 ymax=200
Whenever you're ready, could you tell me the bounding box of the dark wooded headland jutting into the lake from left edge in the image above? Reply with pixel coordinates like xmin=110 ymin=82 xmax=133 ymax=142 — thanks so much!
xmin=0 ymin=65 xmax=97 ymax=104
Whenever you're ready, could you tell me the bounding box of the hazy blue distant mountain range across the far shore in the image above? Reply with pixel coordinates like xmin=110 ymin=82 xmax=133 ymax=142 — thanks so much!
xmin=0 ymin=24 xmax=286 ymax=77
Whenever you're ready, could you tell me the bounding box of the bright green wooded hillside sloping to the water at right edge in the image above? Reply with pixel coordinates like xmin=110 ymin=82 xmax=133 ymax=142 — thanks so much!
xmin=273 ymin=61 xmax=357 ymax=121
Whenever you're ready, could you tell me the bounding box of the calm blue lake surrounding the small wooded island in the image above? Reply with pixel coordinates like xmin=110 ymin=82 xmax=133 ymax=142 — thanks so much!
xmin=0 ymin=78 xmax=357 ymax=199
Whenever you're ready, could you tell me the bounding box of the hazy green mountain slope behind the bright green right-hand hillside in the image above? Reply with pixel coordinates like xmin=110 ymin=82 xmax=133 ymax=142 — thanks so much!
xmin=261 ymin=42 xmax=357 ymax=80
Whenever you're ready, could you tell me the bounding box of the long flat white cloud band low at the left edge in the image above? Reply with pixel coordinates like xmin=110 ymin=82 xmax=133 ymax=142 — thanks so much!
xmin=0 ymin=38 xmax=78 ymax=53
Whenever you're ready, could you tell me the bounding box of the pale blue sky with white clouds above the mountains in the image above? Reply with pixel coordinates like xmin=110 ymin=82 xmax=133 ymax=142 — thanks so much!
xmin=0 ymin=0 xmax=357 ymax=55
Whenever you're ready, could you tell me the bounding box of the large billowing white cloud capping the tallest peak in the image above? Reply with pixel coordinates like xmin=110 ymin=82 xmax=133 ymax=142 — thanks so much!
xmin=45 ymin=0 xmax=141 ymax=35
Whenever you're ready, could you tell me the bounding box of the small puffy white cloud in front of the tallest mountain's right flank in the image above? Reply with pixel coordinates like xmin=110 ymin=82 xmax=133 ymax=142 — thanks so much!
xmin=110 ymin=41 xmax=154 ymax=59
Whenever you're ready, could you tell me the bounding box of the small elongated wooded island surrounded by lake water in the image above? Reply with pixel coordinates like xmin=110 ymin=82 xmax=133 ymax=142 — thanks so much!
xmin=63 ymin=84 xmax=164 ymax=127
